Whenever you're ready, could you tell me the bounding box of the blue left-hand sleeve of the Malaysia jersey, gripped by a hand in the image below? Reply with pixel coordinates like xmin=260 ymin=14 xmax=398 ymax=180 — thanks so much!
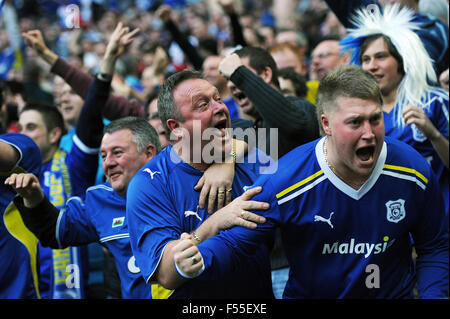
xmin=198 ymin=180 xmax=280 ymax=280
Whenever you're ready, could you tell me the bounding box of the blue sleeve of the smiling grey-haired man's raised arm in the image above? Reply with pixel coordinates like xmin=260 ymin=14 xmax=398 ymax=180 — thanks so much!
xmin=56 ymin=193 xmax=99 ymax=247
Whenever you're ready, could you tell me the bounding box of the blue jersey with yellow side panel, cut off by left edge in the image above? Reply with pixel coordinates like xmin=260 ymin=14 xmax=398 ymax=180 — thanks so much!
xmin=0 ymin=133 xmax=42 ymax=299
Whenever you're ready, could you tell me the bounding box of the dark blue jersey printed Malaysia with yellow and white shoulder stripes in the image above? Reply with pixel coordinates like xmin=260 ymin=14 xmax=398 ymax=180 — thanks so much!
xmin=199 ymin=137 xmax=448 ymax=298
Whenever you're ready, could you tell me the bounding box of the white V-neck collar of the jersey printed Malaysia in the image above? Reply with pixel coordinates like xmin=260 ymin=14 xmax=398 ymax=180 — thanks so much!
xmin=316 ymin=136 xmax=387 ymax=200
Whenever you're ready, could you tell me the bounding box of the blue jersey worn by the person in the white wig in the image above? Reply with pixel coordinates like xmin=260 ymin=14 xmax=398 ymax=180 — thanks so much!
xmin=384 ymin=93 xmax=450 ymax=215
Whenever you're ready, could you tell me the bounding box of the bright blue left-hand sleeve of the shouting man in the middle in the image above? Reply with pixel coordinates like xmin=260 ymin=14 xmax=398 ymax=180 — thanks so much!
xmin=126 ymin=171 xmax=182 ymax=281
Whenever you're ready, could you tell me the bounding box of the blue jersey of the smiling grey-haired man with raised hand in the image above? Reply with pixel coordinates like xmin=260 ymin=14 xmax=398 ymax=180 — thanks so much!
xmin=56 ymin=183 xmax=152 ymax=299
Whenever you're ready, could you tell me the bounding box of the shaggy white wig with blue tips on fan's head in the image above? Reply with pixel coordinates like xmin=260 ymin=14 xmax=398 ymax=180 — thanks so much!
xmin=340 ymin=4 xmax=448 ymax=127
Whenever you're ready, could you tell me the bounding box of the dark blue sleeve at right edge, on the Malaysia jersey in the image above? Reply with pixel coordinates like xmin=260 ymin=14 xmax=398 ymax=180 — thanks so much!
xmin=412 ymin=165 xmax=449 ymax=299
